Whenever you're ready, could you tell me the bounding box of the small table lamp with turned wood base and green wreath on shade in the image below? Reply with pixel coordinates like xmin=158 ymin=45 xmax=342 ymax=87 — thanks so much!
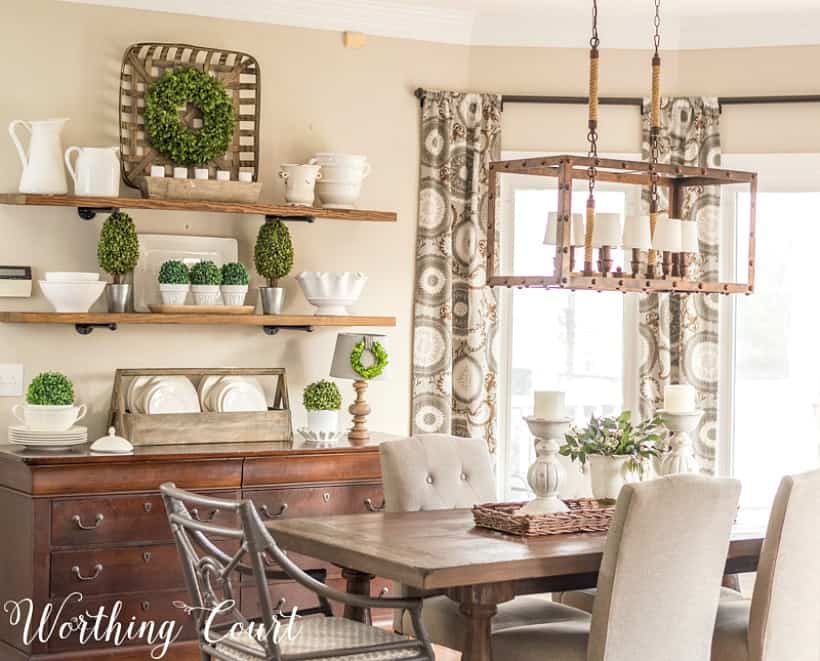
xmin=330 ymin=333 xmax=389 ymax=446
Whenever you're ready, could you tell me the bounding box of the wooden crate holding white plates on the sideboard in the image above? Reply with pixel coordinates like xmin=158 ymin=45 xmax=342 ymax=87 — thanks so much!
xmin=111 ymin=368 xmax=293 ymax=446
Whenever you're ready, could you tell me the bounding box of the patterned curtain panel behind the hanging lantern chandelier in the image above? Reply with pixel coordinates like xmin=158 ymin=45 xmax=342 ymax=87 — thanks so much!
xmin=639 ymin=97 xmax=720 ymax=474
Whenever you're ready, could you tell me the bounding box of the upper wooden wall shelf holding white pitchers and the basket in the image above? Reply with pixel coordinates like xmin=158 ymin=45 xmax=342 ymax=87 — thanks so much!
xmin=0 ymin=193 xmax=397 ymax=222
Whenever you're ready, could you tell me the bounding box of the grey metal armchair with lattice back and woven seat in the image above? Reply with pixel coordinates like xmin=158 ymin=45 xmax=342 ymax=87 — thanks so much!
xmin=160 ymin=483 xmax=435 ymax=661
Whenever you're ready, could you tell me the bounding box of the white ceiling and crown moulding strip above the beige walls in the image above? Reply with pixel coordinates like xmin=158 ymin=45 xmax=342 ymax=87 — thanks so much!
xmin=64 ymin=0 xmax=820 ymax=49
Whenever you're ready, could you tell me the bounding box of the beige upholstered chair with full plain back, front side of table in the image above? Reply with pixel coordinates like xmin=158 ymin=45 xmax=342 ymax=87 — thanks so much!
xmin=493 ymin=475 xmax=740 ymax=661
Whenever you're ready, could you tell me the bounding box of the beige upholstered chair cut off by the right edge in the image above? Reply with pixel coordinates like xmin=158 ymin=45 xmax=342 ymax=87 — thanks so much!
xmin=712 ymin=471 xmax=820 ymax=661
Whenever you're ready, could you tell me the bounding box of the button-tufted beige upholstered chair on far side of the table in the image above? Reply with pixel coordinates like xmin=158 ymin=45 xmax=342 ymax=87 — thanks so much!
xmin=379 ymin=434 xmax=580 ymax=650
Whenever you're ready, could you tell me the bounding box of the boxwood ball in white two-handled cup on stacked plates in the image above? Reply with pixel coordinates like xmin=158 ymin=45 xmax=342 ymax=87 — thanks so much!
xmin=12 ymin=372 xmax=86 ymax=431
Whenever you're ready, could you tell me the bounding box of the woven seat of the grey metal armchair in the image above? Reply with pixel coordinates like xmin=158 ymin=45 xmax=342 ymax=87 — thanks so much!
xmin=216 ymin=617 xmax=419 ymax=661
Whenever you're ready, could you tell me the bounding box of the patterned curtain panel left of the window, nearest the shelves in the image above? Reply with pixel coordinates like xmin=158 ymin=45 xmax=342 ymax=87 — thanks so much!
xmin=413 ymin=91 xmax=501 ymax=450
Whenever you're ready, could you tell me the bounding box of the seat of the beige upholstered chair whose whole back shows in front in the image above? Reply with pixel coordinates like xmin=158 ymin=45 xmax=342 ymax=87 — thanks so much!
xmin=493 ymin=606 xmax=592 ymax=661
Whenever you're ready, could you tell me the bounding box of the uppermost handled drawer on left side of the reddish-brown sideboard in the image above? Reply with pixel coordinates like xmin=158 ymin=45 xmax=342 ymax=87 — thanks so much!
xmin=51 ymin=491 xmax=239 ymax=547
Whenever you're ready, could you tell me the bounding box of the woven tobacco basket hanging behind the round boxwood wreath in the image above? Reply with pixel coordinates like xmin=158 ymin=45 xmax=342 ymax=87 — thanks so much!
xmin=119 ymin=43 xmax=261 ymax=196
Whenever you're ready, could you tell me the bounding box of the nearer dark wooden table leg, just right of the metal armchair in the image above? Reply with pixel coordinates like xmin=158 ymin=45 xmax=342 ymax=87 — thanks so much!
xmin=447 ymin=583 xmax=514 ymax=661
